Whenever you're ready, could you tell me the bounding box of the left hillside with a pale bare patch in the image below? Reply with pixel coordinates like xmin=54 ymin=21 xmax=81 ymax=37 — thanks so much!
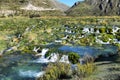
xmin=0 ymin=0 xmax=69 ymax=15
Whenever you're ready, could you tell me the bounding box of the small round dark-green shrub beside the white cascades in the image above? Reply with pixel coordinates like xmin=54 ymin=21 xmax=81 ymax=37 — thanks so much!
xmin=68 ymin=52 xmax=80 ymax=64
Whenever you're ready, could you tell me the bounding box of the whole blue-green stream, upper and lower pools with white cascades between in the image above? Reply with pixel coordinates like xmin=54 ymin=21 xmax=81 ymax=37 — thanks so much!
xmin=0 ymin=45 xmax=117 ymax=80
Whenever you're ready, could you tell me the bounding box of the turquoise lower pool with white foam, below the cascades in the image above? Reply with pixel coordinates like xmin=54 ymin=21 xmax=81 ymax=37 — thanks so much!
xmin=0 ymin=54 xmax=44 ymax=80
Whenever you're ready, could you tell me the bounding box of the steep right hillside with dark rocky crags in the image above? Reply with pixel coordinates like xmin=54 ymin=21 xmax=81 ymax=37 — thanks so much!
xmin=66 ymin=0 xmax=120 ymax=16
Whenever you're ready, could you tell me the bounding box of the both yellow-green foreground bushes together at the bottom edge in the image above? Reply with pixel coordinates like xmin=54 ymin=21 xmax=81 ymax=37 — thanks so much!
xmin=37 ymin=63 xmax=96 ymax=80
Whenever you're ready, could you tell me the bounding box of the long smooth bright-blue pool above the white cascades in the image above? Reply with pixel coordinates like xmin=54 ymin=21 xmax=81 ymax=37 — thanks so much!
xmin=59 ymin=44 xmax=118 ymax=57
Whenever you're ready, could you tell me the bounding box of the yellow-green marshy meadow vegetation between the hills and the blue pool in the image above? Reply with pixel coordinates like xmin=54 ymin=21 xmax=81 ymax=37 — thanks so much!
xmin=0 ymin=17 xmax=120 ymax=55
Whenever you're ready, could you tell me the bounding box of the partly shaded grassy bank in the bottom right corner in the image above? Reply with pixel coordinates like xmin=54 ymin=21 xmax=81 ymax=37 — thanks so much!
xmin=84 ymin=55 xmax=120 ymax=80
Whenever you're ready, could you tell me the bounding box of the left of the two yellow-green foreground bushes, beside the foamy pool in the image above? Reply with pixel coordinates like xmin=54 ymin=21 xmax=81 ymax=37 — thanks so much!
xmin=38 ymin=63 xmax=71 ymax=80
